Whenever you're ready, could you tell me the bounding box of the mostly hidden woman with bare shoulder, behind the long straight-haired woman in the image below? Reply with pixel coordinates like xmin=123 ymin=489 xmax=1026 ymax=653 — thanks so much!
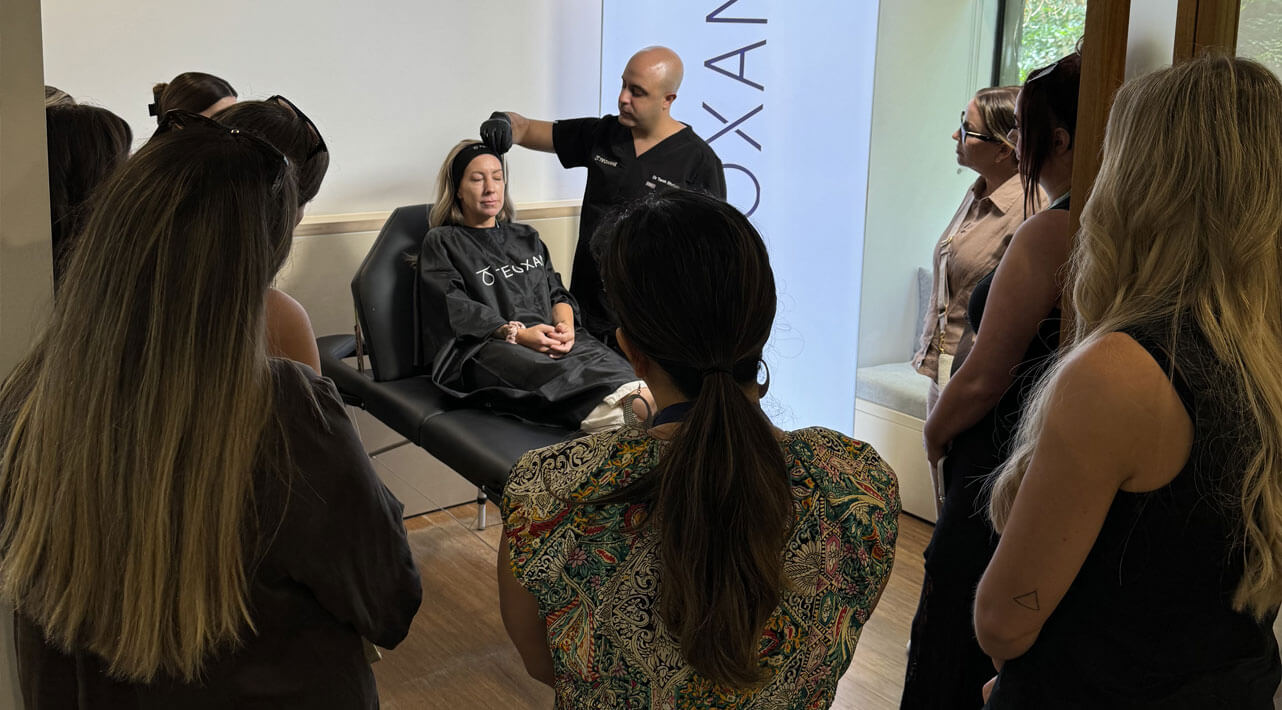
xmin=215 ymin=96 xmax=329 ymax=373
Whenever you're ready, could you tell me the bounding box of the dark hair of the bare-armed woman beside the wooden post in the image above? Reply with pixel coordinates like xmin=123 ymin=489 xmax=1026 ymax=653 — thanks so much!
xmin=1019 ymin=51 xmax=1082 ymax=213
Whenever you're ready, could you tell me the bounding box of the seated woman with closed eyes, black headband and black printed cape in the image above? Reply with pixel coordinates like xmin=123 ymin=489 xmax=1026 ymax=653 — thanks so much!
xmin=418 ymin=141 xmax=650 ymax=432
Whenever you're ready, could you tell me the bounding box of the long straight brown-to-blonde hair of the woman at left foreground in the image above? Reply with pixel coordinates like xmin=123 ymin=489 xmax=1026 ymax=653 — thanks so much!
xmin=0 ymin=126 xmax=297 ymax=682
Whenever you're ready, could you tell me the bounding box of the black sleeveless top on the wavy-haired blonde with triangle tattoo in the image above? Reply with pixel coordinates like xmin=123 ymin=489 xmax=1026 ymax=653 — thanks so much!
xmin=988 ymin=318 xmax=1282 ymax=710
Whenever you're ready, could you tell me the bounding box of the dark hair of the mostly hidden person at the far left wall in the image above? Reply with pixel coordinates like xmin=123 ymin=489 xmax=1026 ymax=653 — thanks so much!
xmin=45 ymin=104 xmax=133 ymax=283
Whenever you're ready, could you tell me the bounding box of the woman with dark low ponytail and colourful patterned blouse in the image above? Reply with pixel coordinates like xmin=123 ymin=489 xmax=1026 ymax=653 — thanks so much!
xmin=499 ymin=191 xmax=899 ymax=709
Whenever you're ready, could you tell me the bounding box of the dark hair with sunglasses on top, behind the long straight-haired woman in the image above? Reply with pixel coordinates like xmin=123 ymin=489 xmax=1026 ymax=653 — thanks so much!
xmin=214 ymin=101 xmax=329 ymax=206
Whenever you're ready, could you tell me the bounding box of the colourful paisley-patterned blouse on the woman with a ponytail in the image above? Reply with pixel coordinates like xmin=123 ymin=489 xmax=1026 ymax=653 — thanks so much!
xmin=503 ymin=427 xmax=900 ymax=710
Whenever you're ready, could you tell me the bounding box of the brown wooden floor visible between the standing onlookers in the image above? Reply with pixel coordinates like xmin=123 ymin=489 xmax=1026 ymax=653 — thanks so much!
xmin=374 ymin=504 xmax=931 ymax=710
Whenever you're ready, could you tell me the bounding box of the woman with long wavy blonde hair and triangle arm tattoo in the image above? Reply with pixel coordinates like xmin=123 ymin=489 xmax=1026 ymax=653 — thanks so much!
xmin=976 ymin=58 xmax=1282 ymax=710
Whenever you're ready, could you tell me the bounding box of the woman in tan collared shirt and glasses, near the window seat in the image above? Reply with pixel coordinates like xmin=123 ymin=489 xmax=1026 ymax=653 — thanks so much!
xmin=913 ymin=86 xmax=1041 ymax=414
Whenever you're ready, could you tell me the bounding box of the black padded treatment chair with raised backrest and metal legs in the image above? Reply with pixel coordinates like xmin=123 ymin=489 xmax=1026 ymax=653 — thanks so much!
xmin=317 ymin=205 xmax=577 ymax=528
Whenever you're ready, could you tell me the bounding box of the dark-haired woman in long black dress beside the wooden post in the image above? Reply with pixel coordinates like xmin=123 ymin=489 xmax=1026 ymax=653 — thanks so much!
xmin=900 ymin=54 xmax=1081 ymax=710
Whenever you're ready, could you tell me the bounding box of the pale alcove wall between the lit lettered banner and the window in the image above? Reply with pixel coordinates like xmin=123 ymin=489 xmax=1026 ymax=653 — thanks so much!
xmin=859 ymin=0 xmax=996 ymax=367
